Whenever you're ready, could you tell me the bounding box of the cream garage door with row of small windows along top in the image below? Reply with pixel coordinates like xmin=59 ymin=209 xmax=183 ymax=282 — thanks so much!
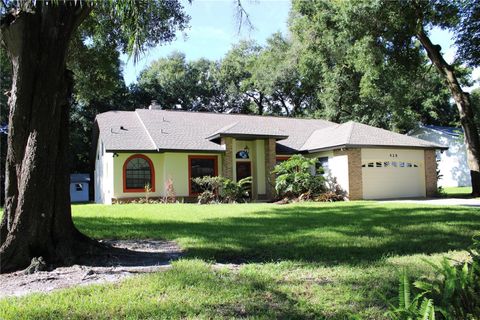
xmin=362 ymin=149 xmax=425 ymax=199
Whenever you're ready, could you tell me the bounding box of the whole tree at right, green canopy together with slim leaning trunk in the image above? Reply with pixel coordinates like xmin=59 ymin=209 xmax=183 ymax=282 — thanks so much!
xmin=292 ymin=0 xmax=480 ymax=196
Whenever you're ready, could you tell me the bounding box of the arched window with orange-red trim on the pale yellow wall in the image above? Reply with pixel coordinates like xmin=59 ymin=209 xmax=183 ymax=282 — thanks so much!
xmin=123 ymin=154 xmax=155 ymax=192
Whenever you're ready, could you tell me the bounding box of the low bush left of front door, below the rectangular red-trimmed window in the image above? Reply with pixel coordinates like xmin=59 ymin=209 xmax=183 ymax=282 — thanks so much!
xmin=192 ymin=176 xmax=252 ymax=204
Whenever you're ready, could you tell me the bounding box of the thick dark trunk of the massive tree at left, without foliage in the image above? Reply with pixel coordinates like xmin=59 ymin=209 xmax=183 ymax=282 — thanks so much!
xmin=0 ymin=1 xmax=95 ymax=273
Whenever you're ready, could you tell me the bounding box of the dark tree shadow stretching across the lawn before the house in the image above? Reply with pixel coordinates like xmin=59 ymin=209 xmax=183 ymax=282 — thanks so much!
xmin=75 ymin=204 xmax=480 ymax=265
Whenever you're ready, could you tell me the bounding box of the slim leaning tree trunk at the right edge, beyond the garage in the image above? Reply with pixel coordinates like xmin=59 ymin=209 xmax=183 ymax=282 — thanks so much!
xmin=417 ymin=29 xmax=480 ymax=197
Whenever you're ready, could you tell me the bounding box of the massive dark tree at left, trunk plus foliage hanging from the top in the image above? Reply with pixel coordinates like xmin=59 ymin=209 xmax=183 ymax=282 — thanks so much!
xmin=0 ymin=0 xmax=188 ymax=273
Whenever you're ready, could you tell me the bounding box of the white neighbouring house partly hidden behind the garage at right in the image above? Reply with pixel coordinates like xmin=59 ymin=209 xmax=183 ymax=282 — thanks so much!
xmin=409 ymin=125 xmax=472 ymax=187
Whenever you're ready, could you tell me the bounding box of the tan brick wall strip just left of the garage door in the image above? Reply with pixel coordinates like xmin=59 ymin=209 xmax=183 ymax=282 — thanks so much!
xmin=333 ymin=149 xmax=363 ymax=200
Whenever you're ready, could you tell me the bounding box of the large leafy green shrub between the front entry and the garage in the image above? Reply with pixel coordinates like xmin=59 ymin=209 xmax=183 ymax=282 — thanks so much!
xmin=273 ymin=155 xmax=325 ymax=200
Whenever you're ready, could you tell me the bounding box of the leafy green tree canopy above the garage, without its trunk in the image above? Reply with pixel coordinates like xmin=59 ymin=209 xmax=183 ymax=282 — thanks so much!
xmin=291 ymin=1 xmax=468 ymax=132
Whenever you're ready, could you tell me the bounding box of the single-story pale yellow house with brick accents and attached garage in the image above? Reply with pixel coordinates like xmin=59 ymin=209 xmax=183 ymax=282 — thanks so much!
xmin=94 ymin=109 xmax=446 ymax=203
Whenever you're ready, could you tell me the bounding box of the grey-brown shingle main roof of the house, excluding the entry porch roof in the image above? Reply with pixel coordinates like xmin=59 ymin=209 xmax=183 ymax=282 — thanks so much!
xmin=97 ymin=109 xmax=448 ymax=153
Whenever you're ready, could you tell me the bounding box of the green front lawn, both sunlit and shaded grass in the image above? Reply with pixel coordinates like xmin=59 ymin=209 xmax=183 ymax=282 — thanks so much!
xmin=0 ymin=202 xmax=480 ymax=319
